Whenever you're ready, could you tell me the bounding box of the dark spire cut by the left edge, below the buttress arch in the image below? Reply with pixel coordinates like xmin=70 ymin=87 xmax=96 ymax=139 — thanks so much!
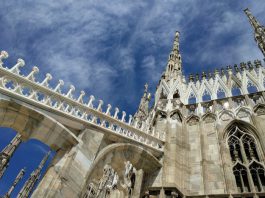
xmin=0 ymin=134 xmax=22 ymax=179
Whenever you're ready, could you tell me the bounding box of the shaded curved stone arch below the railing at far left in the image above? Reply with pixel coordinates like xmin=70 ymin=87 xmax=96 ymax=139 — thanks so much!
xmin=0 ymin=99 xmax=78 ymax=150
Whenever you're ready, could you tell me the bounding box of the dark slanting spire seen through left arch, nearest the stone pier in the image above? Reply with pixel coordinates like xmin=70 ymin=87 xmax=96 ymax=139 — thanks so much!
xmin=18 ymin=151 xmax=51 ymax=198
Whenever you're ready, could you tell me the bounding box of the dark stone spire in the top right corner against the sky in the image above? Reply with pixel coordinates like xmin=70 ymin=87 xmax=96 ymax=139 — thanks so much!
xmin=244 ymin=8 xmax=265 ymax=56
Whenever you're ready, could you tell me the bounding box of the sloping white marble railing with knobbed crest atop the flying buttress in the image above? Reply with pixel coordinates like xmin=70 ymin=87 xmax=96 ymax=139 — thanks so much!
xmin=0 ymin=51 xmax=164 ymax=151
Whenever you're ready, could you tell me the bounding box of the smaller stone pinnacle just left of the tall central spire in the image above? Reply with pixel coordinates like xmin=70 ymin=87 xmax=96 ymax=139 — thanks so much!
xmin=134 ymin=83 xmax=151 ymax=121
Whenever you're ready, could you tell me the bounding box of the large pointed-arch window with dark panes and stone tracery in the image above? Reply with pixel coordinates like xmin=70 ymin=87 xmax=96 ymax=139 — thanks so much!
xmin=227 ymin=125 xmax=265 ymax=192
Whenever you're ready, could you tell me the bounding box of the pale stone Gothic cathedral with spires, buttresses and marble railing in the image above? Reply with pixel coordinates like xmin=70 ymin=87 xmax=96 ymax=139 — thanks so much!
xmin=0 ymin=9 xmax=265 ymax=198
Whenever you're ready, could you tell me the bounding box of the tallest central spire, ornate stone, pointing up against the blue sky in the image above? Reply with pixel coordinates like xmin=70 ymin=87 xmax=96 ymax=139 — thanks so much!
xmin=165 ymin=31 xmax=182 ymax=79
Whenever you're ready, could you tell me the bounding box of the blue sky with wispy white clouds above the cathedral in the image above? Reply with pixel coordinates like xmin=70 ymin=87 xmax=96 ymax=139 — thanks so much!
xmin=0 ymin=0 xmax=265 ymax=196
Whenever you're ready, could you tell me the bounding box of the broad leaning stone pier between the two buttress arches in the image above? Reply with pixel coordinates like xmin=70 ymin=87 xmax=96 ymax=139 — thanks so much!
xmin=32 ymin=129 xmax=104 ymax=198
